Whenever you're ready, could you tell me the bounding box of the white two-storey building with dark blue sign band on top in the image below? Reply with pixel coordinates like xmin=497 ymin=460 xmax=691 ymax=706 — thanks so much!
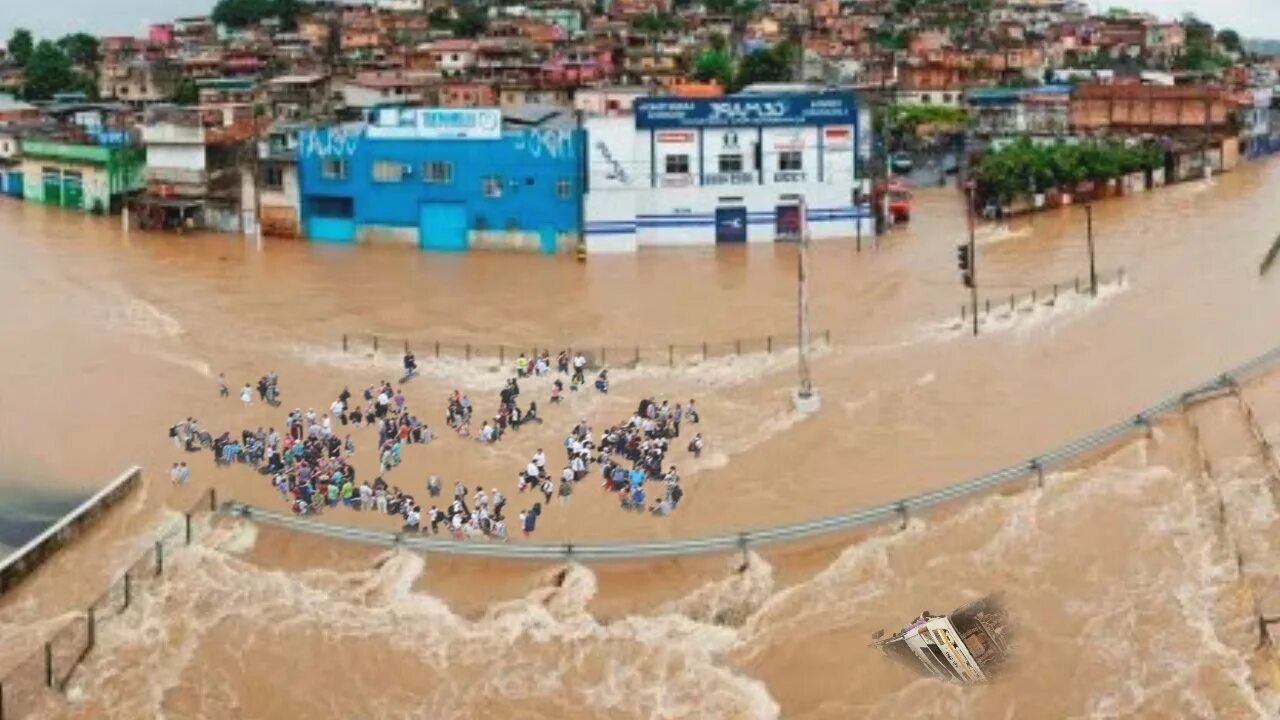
xmin=585 ymin=92 xmax=874 ymax=252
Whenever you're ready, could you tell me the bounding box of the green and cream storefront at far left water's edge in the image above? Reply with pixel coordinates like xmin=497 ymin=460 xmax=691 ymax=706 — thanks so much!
xmin=22 ymin=140 xmax=146 ymax=214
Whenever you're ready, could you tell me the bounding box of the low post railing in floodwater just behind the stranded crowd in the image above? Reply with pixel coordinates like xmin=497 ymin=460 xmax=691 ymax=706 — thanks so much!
xmin=342 ymin=329 xmax=831 ymax=368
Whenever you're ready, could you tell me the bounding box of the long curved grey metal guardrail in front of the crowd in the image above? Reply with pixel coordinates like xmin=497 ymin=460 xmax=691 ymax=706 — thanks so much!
xmin=221 ymin=338 xmax=1280 ymax=561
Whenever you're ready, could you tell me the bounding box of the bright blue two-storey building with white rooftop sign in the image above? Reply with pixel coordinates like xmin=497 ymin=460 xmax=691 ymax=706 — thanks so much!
xmin=298 ymin=108 xmax=584 ymax=252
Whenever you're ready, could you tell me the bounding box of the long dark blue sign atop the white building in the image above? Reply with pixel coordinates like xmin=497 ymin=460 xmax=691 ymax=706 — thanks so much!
xmin=635 ymin=92 xmax=856 ymax=129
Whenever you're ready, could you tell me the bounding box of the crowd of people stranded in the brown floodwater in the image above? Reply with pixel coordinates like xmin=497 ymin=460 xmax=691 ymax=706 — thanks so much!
xmin=183 ymin=351 xmax=703 ymax=541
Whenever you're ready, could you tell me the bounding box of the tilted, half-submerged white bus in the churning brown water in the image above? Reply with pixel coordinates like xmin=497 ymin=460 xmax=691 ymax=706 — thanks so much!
xmin=872 ymin=597 xmax=1011 ymax=685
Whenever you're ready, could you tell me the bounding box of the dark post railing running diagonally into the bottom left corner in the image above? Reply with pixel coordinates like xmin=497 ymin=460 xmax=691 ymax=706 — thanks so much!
xmin=0 ymin=481 xmax=218 ymax=720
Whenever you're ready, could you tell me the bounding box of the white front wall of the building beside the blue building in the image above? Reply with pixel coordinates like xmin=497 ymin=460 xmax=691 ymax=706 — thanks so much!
xmin=586 ymin=117 xmax=874 ymax=252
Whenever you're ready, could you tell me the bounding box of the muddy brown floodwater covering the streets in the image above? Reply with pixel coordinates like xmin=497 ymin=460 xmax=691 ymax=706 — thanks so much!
xmin=0 ymin=164 xmax=1280 ymax=717
